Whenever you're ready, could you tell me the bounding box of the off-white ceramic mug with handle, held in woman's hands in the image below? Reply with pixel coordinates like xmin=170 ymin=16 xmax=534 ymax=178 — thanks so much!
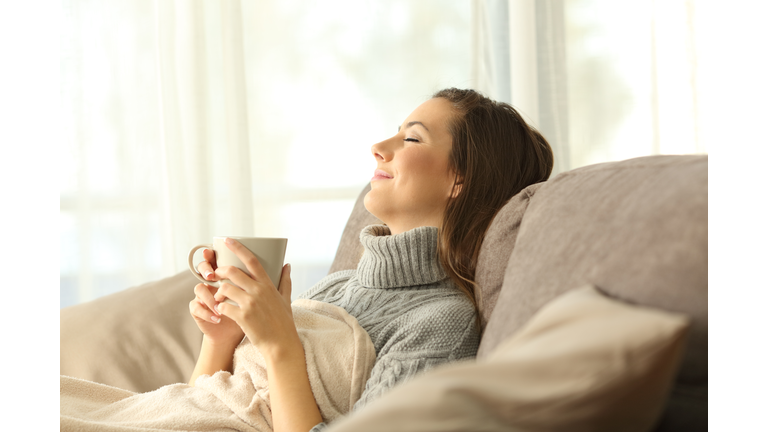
xmin=189 ymin=236 xmax=288 ymax=306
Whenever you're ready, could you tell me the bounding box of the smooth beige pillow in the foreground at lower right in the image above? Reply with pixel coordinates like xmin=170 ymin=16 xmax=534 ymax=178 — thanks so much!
xmin=328 ymin=286 xmax=689 ymax=432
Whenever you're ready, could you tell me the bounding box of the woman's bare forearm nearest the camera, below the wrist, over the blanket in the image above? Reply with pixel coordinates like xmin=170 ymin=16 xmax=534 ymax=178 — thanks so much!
xmin=265 ymin=341 xmax=323 ymax=432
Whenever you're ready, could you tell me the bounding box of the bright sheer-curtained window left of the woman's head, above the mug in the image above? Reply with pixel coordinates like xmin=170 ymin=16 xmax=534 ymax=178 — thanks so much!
xmin=59 ymin=0 xmax=471 ymax=307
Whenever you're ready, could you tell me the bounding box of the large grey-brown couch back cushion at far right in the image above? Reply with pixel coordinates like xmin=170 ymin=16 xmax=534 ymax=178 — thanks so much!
xmin=478 ymin=155 xmax=708 ymax=430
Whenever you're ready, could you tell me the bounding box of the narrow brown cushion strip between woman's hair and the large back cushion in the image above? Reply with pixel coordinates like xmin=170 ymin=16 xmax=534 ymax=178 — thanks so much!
xmin=475 ymin=183 xmax=543 ymax=329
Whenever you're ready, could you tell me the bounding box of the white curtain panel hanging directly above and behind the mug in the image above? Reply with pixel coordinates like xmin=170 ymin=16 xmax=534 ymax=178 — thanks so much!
xmin=155 ymin=0 xmax=254 ymax=274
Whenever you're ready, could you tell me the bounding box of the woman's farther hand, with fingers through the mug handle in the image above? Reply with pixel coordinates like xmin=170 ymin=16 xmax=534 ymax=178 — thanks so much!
xmin=189 ymin=249 xmax=244 ymax=346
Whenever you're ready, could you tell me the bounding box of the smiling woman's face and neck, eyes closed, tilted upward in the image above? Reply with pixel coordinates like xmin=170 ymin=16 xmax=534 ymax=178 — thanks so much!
xmin=364 ymin=98 xmax=455 ymax=234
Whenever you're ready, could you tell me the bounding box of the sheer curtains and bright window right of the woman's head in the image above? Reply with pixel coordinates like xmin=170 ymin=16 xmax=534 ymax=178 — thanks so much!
xmin=472 ymin=0 xmax=709 ymax=174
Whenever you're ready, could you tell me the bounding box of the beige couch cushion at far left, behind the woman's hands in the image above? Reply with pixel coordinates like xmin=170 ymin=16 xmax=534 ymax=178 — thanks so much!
xmin=60 ymin=270 xmax=203 ymax=392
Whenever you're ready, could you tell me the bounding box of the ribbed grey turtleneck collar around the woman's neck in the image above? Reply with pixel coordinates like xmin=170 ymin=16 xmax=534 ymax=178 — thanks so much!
xmin=357 ymin=225 xmax=448 ymax=288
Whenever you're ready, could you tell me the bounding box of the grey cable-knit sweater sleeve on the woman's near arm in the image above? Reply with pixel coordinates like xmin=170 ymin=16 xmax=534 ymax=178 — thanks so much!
xmin=353 ymin=305 xmax=480 ymax=411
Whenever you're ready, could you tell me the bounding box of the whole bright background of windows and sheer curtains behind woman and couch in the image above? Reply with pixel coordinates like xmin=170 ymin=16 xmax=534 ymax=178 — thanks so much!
xmin=58 ymin=0 xmax=712 ymax=307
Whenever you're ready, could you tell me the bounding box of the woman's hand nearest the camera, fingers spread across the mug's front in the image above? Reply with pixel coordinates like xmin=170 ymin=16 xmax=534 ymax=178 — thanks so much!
xmin=213 ymin=239 xmax=303 ymax=359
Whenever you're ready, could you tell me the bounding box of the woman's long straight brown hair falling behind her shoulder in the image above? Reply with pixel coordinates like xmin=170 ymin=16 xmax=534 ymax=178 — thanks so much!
xmin=432 ymin=88 xmax=554 ymax=323
